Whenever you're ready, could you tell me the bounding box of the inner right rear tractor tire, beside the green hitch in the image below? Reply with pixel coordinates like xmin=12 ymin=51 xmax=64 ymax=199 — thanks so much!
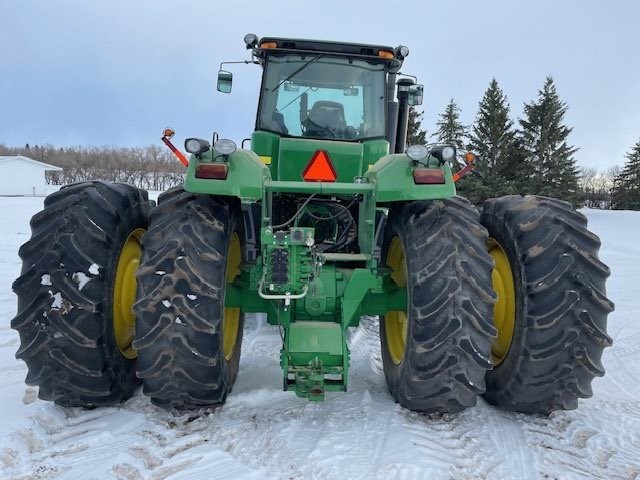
xmin=380 ymin=197 xmax=496 ymax=413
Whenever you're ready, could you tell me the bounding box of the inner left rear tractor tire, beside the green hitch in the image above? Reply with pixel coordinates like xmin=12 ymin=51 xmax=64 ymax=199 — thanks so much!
xmin=133 ymin=188 xmax=244 ymax=410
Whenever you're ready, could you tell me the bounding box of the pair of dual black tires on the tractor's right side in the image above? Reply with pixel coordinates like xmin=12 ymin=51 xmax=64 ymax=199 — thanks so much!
xmin=380 ymin=196 xmax=613 ymax=413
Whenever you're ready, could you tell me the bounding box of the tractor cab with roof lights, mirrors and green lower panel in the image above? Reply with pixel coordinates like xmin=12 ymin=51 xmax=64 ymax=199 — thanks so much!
xmin=218 ymin=34 xmax=422 ymax=182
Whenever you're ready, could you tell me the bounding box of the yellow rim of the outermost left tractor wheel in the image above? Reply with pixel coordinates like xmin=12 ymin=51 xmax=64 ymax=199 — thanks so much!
xmin=113 ymin=228 xmax=144 ymax=359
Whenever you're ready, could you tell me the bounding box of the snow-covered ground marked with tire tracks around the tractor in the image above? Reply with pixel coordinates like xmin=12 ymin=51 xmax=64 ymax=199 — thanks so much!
xmin=0 ymin=198 xmax=640 ymax=480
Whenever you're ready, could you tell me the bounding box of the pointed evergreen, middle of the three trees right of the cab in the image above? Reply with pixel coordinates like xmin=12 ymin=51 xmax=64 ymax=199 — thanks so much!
xmin=457 ymin=78 xmax=519 ymax=203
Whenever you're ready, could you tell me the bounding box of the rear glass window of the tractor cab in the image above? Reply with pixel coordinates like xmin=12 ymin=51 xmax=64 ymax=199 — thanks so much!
xmin=256 ymin=54 xmax=386 ymax=142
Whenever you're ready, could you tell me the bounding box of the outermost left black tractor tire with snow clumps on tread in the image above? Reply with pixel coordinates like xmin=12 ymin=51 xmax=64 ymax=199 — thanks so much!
xmin=11 ymin=182 xmax=149 ymax=407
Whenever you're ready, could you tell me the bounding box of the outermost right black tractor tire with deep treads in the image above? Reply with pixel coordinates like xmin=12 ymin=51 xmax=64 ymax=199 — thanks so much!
xmin=481 ymin=195 xmax=614 ymax=414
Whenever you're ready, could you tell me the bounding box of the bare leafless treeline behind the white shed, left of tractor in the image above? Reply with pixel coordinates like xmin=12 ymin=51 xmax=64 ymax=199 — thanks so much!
xmin=0 ymin=144 xmax=185 ymax=190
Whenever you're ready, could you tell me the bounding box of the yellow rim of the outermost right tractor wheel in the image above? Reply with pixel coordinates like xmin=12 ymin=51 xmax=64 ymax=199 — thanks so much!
xmin=487 ymin=238 xmax=516 ymax=365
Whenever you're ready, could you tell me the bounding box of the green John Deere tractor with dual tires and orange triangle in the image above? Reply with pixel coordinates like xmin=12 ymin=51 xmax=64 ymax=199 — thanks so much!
xmin=11 ymin=34 xmax=613 ymax=412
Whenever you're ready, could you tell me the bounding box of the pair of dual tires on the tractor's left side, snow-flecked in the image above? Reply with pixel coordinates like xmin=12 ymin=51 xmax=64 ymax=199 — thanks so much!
xmin=11 ymin=182 xmax=243 ymax=408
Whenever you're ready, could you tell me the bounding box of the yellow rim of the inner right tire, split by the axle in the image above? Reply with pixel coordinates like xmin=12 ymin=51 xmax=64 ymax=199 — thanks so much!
xmin=384 ymin=236 xmax=409 ymax=365
